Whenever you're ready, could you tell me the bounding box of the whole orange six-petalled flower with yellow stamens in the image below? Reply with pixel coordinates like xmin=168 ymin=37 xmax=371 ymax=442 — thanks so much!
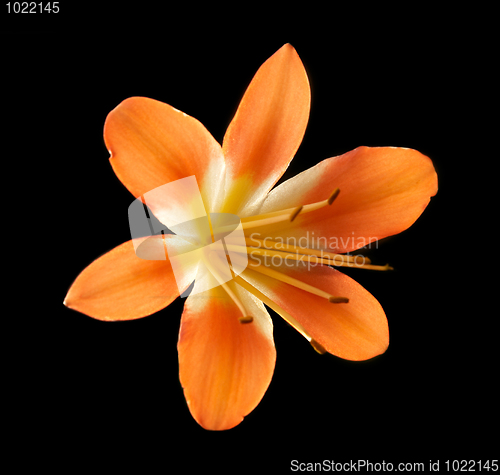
xmin=64 ymin=44 xmax=437 ymax=430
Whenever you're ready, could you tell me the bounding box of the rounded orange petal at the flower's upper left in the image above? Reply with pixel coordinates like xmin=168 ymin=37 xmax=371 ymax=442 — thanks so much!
xmin=104 ymin=97 xmax=224 ymax=212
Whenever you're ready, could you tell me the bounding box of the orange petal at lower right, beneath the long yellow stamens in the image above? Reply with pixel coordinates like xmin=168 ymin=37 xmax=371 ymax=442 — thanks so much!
xmin=241 ymin=263 xmax=389 ymax=360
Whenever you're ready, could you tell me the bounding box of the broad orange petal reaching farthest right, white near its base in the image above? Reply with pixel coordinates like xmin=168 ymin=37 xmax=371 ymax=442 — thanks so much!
xmin=259 ymin=147 xmax=437 ymax=252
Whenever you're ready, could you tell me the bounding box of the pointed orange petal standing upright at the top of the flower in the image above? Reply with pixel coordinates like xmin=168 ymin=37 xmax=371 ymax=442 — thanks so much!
xmin=222 ymin=44 xmax=310 ymax=215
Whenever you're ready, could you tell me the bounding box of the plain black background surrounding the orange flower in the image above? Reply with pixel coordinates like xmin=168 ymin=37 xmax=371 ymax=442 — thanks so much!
xmin=4 ymin=3 xmax=499 ymax=473
